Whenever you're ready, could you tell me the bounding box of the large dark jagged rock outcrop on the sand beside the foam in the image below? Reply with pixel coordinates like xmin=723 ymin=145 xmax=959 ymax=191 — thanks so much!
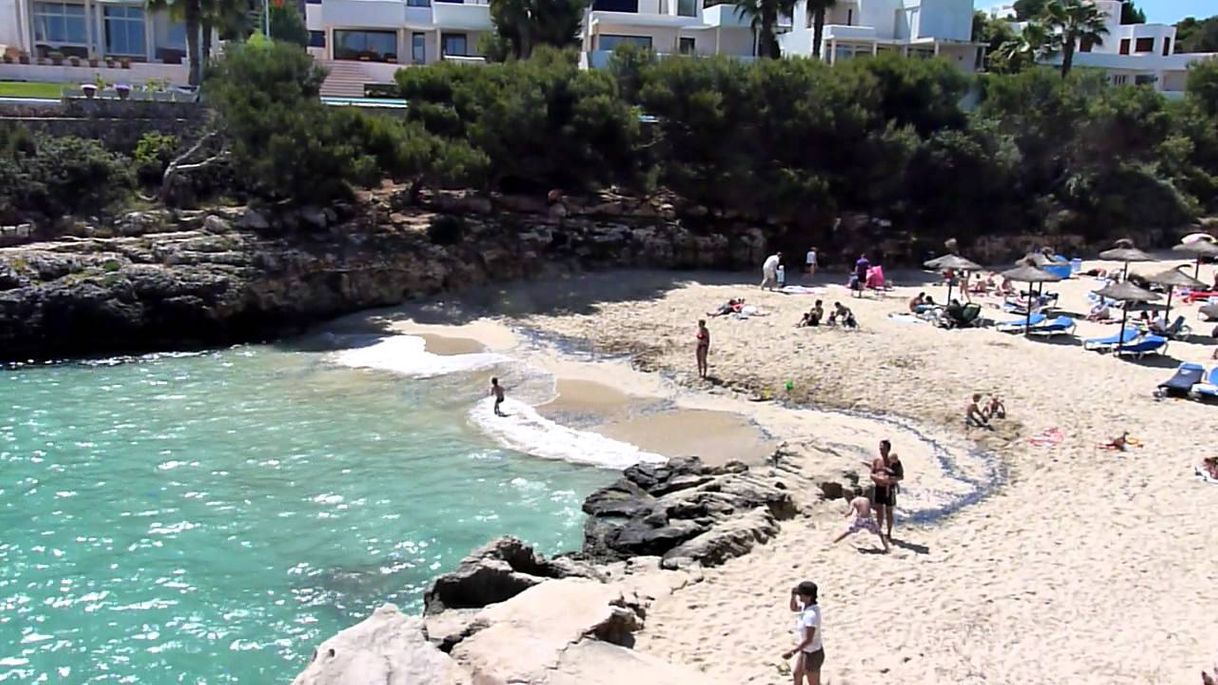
xmin=583 ymin=457 xmax=797 ymax=568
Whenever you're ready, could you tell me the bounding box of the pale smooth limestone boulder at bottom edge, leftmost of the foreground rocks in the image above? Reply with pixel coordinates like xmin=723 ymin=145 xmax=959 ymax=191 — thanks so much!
xmin=292 ymin=605 xmax=471 ymax=685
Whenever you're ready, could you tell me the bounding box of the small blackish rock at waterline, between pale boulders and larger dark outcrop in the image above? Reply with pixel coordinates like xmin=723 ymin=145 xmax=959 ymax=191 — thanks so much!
xmin=423 ymin=538 xmax=602 ymax=614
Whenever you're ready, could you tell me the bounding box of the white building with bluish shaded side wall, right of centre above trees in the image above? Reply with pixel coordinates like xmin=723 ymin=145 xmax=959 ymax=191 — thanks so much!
xmin=778 ymin=0 xmax=984 ymax=72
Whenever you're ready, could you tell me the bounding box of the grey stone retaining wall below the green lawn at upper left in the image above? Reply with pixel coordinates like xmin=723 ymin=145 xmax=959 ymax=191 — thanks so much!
xmin=0 ymin=99 xmax=207 ymax=154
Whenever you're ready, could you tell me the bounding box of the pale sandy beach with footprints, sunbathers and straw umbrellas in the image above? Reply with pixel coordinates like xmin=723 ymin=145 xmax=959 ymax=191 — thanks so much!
xmin=341 ymin=257 xmax=1218 ymax=684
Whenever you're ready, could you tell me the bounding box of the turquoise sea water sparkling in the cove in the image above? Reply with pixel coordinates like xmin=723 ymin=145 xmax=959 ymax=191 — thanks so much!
xmin=0 ymin=347 xmax=614 ymax=684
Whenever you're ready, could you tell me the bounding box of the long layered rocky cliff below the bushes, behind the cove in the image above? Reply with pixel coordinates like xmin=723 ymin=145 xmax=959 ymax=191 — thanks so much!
xmin=0 ymin=186 xmax=765 ymax=361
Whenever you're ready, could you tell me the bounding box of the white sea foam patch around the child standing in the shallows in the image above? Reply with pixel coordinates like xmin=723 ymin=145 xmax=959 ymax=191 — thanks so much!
xmin=469 ymin=397 xmax=667 ymax=469
